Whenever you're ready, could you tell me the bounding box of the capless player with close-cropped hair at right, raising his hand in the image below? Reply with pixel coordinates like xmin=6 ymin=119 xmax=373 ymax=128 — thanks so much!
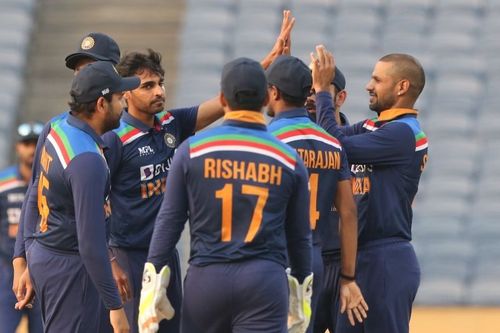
xmin=311 ymin=46 xmax=428 ymax=333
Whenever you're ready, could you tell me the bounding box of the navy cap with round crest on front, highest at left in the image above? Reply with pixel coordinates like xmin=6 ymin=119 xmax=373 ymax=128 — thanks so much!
xmin=65 ymin=32 xmax=120 ymax=70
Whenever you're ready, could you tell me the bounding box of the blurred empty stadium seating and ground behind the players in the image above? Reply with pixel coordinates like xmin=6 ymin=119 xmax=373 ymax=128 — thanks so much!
xmin=0 ymin=0 xmax=500 ymax=333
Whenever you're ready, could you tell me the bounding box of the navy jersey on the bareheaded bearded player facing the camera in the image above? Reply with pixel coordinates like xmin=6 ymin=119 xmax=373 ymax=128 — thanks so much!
xmin=103 ymin=107 xmax=198 ymax=249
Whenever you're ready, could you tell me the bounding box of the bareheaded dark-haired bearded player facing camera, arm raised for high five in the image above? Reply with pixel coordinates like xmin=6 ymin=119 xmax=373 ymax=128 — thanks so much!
xmin=103 ymin=11 xmax=294 ymax=332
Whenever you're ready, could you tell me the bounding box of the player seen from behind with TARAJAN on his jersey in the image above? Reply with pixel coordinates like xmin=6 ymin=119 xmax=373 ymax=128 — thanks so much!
xmin=266 ymin=56 xmax=368 ymax=332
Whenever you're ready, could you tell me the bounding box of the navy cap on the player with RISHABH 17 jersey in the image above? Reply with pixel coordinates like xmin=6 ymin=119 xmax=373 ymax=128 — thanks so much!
xmin=220 ymin=58 xmax=267 ymax=108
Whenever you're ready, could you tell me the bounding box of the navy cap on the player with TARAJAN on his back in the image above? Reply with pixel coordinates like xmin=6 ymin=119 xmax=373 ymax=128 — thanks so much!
xmin=266 ymin=55 xmax=312 ymax=99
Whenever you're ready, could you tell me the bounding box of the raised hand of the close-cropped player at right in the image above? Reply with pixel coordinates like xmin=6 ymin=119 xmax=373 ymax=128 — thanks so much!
xmin=309 ymin=45 xmax=335 ymax=93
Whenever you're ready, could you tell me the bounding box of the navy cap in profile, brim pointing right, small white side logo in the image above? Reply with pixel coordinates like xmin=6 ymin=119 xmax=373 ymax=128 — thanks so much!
xmin=70 ymin=61 xmax=141 ymax=103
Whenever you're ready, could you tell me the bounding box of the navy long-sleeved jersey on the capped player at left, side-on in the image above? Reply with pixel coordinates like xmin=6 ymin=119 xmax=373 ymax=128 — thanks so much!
xmin=28 ymin=114 xmax=122 ymax=309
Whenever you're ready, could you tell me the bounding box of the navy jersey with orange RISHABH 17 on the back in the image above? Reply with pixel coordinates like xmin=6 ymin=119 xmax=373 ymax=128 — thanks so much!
xmin=148 ymin=111 xmax=312 ymax=279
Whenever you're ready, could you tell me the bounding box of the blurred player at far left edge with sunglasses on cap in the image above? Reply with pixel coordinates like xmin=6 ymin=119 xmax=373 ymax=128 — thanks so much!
xmin=0 ymin=122 xmax=43 ymax=333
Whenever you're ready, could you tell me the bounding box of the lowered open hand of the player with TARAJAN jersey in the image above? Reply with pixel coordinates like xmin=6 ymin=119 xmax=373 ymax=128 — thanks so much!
xmin=340 ymin=280 xmax=368 ymax=326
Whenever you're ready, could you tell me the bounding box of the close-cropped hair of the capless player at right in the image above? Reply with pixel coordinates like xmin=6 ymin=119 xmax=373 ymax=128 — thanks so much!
xmin=379 ymin=53 xmax=425 ymax=99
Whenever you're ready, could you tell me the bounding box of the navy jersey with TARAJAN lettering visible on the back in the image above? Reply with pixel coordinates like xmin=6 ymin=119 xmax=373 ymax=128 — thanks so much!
xmin=269 ymin=108 xmax=351 ymax=245
